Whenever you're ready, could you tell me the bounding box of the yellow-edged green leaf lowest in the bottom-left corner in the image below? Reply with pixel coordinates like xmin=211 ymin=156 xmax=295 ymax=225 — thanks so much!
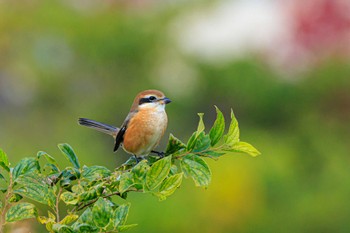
xmin=5 ymin=202 xmax=38 ymax=222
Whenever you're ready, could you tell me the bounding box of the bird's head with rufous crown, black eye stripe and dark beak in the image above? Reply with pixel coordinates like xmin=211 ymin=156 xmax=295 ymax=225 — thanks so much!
xmin=132 ymin=90 xmax=171 ymax=109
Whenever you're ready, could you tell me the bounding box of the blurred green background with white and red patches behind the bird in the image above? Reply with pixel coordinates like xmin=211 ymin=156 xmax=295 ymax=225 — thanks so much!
xmin=0 ymin=0 xmax=350 ymax=233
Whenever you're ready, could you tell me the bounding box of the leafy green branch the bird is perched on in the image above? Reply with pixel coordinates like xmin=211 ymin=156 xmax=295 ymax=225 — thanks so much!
xmin=0 ymin=107 xmax=259 ymax=232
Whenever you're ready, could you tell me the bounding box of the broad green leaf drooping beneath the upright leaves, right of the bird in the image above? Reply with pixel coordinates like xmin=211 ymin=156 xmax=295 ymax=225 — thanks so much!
xmin=181 ymin=154 xmax=211 ymax=187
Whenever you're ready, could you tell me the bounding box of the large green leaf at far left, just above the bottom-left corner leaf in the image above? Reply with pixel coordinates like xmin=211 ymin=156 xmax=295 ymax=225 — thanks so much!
xmin=14 ymin=174 xmax=56 ymax=208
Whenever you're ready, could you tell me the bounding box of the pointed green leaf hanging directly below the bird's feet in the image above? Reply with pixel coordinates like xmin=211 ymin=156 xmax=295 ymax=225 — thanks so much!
xmin=146 ymin=156 xmax=171 ymax=190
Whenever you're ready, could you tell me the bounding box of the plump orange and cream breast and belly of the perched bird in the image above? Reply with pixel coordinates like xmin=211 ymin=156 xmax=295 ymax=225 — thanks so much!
xmin=123 ymin=109 xmax=168 ymax=156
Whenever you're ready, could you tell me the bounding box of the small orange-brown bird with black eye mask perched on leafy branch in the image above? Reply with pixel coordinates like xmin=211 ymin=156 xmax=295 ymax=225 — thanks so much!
xmin=78 ymin=90 xmax=171 ymax=160
